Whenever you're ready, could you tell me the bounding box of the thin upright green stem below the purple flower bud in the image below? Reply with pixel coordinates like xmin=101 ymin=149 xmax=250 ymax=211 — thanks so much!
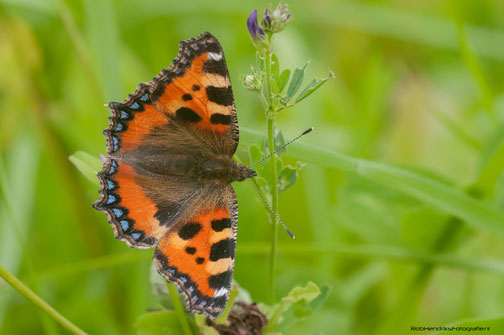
xmin=264 ymin=35 xmax=278 ymax=305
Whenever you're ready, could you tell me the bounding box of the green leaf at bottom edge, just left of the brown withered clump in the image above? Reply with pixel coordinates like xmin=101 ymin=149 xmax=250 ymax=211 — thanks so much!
xmin=135 ymin=310 xmax=199 ymax=335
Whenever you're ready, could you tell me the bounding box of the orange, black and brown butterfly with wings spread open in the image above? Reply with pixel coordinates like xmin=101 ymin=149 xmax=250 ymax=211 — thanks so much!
xmin=93 ymin=32 xmax=256 ymax=319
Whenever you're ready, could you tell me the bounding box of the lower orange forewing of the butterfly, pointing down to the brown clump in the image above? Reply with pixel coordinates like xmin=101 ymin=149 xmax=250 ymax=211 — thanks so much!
xmin=154 ymin=185 xmax=238 ymax=318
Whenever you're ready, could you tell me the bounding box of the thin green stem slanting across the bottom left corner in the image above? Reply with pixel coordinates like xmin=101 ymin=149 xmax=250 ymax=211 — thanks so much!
xmin=0 ymin=265 xmax=86 ymax=334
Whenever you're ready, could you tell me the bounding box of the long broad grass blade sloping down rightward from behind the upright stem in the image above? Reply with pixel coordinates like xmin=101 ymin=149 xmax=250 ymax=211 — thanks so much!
xmin=240 ymin=128 xmax=504 ymax=236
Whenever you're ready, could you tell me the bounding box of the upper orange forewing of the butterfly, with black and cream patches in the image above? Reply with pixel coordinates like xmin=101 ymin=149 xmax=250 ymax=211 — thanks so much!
xmin=151 ymin=33 xmax=238 ymax=156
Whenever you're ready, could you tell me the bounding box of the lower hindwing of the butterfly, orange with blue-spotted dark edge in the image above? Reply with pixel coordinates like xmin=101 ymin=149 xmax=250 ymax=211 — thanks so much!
xmin=94 ymin=155 xmax=208 ymax=248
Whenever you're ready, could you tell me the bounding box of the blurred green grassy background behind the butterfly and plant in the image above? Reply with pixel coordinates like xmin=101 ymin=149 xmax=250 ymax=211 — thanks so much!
xmin=0 ymin=0 xmax=504 ymax=334
